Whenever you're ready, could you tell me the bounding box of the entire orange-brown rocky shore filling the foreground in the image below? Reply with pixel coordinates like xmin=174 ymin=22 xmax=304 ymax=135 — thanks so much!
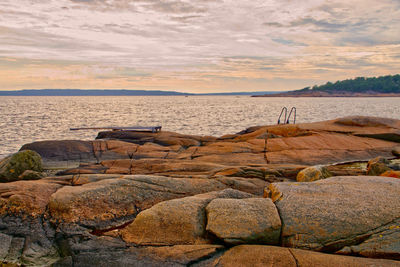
xmin=0 ymin=117 xmax=400 ymax=266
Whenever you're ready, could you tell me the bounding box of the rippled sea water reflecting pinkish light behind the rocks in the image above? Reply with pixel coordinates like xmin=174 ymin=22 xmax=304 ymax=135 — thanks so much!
xmin=0 ymin=96 xmax=400 ymax=158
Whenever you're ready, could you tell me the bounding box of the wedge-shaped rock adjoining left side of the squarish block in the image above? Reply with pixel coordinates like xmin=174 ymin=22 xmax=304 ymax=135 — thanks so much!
xmin=121 ymin=189 xmax=252 ymax=245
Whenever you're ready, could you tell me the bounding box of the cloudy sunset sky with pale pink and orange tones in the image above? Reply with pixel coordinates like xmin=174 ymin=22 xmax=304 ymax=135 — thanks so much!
xmin=0 ymin=0 xmax=400 ymax=93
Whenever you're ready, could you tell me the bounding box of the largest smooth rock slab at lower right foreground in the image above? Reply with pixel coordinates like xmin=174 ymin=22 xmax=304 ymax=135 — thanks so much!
xmin=269 ymin=176 xmax=400 ymax=257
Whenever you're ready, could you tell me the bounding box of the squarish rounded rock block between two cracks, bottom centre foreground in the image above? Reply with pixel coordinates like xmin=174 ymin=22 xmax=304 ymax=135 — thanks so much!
xmin=206 ymin=198 xmax=281 ymax=245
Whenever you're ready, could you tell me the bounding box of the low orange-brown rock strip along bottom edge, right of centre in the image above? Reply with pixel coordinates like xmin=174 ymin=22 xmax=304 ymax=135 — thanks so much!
xmin=208 ymin=245 xmax=400 ymax=267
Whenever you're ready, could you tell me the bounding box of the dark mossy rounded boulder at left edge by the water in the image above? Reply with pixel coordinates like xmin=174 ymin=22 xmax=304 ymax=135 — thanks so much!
xmin=0 ymin=150 xmax=43 ymax=182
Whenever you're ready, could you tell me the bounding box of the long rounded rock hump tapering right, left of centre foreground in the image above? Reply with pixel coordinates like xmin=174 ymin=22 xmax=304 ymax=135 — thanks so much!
xmin=49 ymin=175 xmax=227 ymax=229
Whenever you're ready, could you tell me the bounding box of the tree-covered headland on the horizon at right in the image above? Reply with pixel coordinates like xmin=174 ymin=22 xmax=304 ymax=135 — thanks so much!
xmin=253 ymin=74 xmax=400 ymax=97
